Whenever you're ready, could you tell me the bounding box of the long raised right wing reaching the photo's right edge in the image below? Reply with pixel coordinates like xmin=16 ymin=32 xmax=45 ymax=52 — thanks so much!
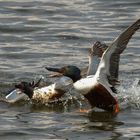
xmin=96 ymin=19 xmax=140 ymax=86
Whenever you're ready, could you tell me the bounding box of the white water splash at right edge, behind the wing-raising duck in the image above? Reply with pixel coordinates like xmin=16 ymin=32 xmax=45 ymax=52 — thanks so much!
xmin=118 ymin=78 xmax=140 ymax=110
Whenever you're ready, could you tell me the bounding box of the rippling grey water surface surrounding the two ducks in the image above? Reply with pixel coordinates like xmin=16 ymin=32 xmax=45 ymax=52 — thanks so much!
xmin=0 ymin=0 xmax=140 ymax=140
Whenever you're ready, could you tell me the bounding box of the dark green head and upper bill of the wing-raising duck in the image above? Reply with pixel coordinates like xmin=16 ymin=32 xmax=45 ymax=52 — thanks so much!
xmin=45 ymin=65 xmax=81 ymax=82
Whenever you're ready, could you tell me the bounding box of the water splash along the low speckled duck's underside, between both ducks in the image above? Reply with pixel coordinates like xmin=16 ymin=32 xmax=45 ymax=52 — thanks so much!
xmin=30 ymin=90 xmax=84 ymax=111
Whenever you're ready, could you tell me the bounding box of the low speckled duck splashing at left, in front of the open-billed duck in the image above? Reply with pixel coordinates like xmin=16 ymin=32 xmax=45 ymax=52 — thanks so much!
xmin=6 ymin=75 xmax=73 ymax=104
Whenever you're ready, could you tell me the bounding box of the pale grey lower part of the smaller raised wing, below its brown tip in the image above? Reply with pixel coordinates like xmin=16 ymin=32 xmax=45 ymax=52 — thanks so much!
xmin=87 ymin=55 xmax=100 ymax=76
